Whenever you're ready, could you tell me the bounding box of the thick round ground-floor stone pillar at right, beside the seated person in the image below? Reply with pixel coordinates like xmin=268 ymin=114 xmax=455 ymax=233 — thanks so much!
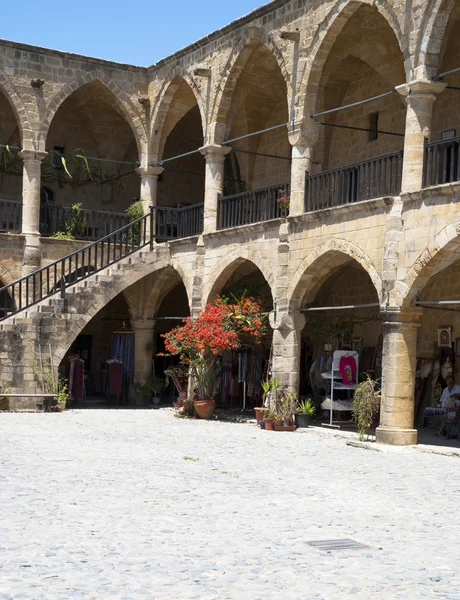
xmin=376 ymin=308 xmax=422 ymax=446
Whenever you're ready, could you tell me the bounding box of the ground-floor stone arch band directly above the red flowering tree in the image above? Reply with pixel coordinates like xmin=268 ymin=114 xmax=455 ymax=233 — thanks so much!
xmin=202 ymin=248 xmax=275 ymax=307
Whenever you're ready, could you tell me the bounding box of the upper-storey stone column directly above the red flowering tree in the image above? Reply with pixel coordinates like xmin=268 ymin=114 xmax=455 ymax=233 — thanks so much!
xmin=200 ymin=144 xmax=231 ymax=233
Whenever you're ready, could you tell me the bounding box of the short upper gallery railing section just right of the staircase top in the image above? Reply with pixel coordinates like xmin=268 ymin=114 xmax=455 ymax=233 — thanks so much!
xmin=154 ymin=204 xmax=204 ymax=240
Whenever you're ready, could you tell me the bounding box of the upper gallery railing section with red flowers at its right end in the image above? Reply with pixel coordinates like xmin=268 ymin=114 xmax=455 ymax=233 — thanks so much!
xmin=217 ymin=183 xmax=289 ymax=229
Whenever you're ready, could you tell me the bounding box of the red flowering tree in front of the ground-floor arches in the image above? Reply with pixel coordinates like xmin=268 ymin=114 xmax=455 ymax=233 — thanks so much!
xmin=163 ymin=296 xmax=265 ymax=400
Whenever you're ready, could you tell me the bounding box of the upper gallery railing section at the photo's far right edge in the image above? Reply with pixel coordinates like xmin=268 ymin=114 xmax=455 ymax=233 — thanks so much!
xmin=423 ymin=137 xmax=460 ymax=187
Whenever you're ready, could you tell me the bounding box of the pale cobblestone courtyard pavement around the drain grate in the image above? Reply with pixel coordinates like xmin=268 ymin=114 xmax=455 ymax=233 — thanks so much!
xmin=0 ymin=410 xmax=460 ymax=600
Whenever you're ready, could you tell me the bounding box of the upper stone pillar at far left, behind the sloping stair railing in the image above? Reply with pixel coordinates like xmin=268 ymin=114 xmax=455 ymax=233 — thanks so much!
xmin=19 ymin=150 xmax=47 ymax=276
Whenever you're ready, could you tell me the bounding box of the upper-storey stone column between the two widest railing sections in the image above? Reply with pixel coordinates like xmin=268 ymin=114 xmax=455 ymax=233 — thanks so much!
xmin=289 ymin=121 xmax=320 ymax=216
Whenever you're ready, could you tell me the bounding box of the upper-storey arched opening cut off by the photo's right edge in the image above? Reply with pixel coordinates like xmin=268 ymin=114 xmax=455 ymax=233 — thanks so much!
xmin=425 ymin=3 xmax=460 ymax=185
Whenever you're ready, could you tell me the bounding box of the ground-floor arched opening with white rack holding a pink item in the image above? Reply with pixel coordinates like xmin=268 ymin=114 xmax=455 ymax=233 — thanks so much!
xmin=300 ymin=252 xmax=383 ymax=428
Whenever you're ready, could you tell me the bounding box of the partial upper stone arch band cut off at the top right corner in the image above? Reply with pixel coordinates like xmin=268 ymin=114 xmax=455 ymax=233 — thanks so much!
xmin=415 ymin=0 xmax=455 ymax=76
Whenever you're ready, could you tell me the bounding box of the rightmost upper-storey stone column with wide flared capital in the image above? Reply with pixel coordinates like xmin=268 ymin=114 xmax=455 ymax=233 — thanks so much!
xmin=396 ymin=80 xmax=447 ymax=192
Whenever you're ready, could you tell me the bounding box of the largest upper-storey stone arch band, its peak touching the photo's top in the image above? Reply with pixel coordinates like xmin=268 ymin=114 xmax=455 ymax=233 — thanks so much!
xmin=299 ymin=0 xmax=411 ymax=119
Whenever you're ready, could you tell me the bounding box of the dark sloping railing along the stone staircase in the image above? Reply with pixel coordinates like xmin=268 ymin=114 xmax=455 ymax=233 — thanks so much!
xmin=0 ymin=208 xmax=155 ymax=321
